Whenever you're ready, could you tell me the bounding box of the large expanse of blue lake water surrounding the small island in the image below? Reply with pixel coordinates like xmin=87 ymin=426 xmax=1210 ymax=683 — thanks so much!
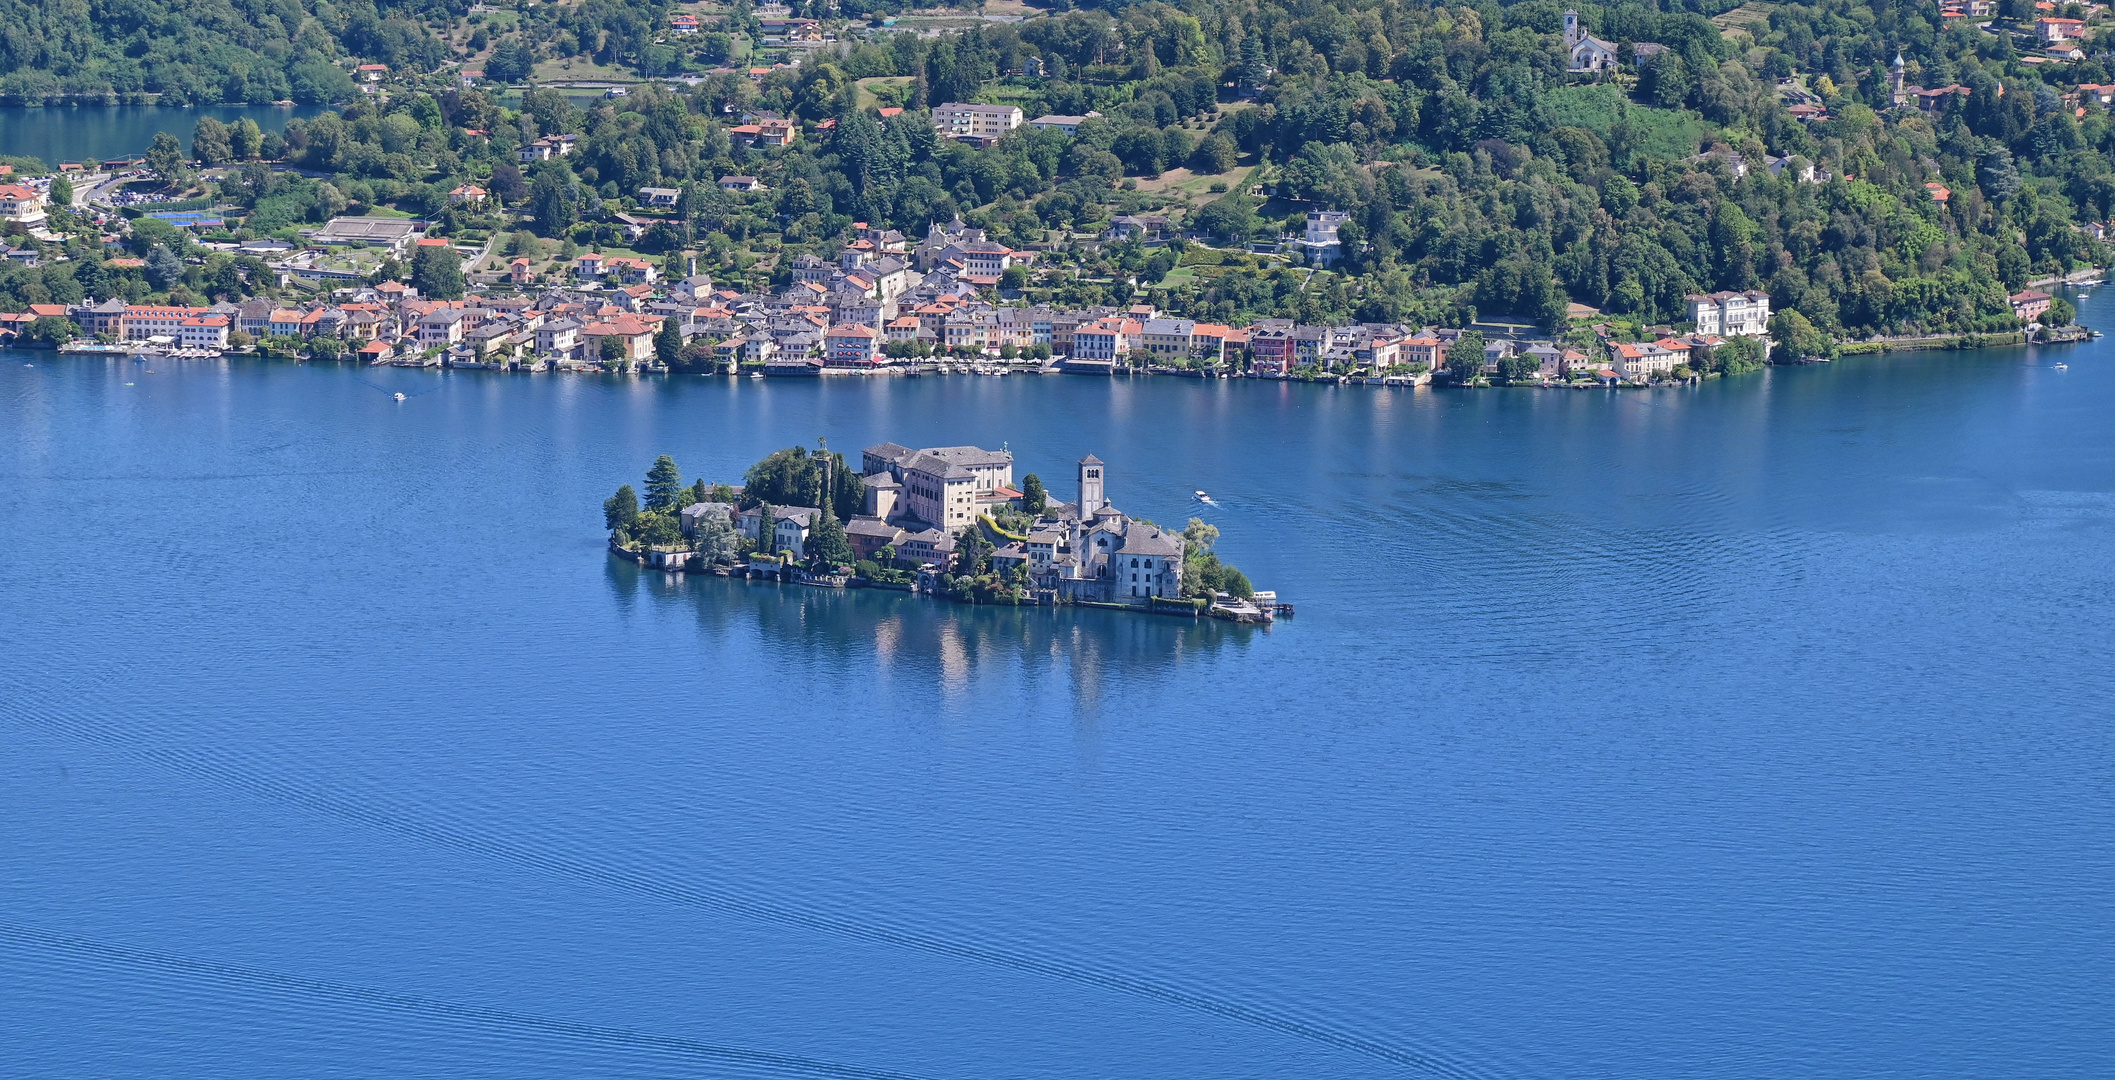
xmin=0 ymin=298 xmax=2115 ymax=1080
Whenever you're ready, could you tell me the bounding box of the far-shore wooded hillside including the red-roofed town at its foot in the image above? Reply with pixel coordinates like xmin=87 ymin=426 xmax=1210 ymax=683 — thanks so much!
xmin=0 ymin=0 xmax=2115 ymax=376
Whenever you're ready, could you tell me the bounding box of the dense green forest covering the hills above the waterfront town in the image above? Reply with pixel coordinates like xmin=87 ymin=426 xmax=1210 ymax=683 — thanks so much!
xmin=0 ymin=0 xmax=2115 ymax=336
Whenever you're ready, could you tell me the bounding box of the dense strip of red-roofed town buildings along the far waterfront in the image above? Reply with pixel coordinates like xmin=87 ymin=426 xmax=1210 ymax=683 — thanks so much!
xmin=12 ymin=186 xmax=2098 ymax=385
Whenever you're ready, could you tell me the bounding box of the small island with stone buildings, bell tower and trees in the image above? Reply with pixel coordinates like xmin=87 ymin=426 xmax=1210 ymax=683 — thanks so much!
xmin=603 ymin=442 xmax=1290 ymax=623
